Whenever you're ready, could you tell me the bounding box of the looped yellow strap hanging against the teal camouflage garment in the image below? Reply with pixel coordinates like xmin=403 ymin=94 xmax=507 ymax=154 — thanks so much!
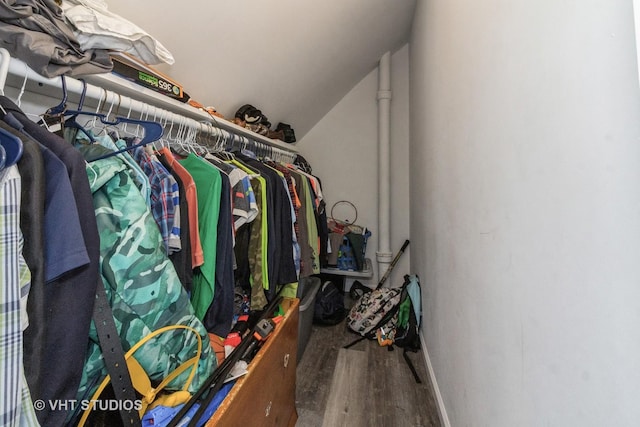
xmin=78 ymin=325 xmax=202 ymax=427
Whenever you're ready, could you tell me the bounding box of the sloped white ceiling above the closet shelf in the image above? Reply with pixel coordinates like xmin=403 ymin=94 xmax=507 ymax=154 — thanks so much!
xmin=107 ymin=0 xmax=415 ymax=139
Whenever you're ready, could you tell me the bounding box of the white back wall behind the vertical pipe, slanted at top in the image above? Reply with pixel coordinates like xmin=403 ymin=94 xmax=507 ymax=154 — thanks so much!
xmin=297 ymin=45 xmax=411 ymax=286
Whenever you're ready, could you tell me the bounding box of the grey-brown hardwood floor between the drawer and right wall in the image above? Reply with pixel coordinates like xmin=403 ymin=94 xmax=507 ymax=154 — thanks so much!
xmin=296 ymin=296 xmax=441 ymax=427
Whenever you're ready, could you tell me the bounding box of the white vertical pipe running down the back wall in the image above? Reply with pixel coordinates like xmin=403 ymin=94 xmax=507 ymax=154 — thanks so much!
xmin=376 ymin=52 xmax=393 ymax=278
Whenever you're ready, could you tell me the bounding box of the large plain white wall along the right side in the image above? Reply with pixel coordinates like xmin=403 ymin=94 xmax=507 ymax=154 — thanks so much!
xmin=410 ymin=0 xmax=640 ymax=427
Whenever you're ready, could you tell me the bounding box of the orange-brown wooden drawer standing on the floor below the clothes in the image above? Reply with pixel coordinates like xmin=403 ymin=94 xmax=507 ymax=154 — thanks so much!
xmin=206 ymin=299 xmax=299 ymax=427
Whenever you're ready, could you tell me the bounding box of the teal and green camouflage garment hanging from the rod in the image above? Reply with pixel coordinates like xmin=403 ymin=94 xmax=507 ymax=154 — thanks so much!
xmin=72 ymin=144 xmax=215 ymax=400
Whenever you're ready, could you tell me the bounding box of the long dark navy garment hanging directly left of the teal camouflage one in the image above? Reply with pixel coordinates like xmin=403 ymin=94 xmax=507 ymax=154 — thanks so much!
xmin=0 ymin=97 xmax=102 ymax=426
